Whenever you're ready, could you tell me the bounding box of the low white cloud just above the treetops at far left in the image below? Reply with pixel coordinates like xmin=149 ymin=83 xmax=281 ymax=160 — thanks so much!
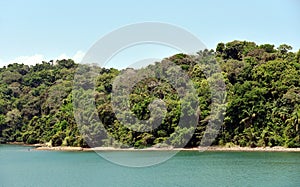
xmin=0 ymin=51 xmax=85 ymax=67
